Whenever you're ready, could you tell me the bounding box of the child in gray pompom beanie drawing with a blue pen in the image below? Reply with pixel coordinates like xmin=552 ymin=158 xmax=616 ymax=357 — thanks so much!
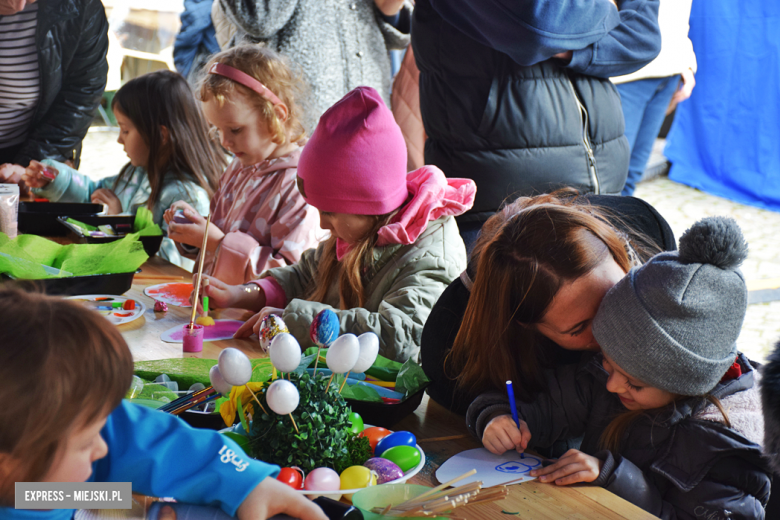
xmin=467 ymin=217 xmax=771 ymax=519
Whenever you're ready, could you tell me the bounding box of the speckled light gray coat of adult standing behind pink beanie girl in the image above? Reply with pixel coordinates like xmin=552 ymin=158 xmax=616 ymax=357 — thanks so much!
xmin=220 ymin=0 xmax=412 ymax=129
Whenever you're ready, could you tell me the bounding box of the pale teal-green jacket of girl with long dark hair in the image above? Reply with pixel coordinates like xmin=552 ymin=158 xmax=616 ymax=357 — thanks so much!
xmin=33 ymin=159 xmax=209 ymax=271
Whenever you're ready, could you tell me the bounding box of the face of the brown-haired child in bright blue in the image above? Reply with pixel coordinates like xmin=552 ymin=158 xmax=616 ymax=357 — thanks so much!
xmin=42 ymin=415 xmax=108 ymax=482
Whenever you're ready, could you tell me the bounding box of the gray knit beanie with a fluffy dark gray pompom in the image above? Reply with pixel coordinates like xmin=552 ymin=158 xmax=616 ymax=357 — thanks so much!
xmin=593 ymin=217 xmax=747 ymax=395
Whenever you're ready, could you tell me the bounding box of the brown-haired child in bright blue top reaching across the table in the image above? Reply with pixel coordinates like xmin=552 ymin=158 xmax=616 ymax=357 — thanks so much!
xmin=0 ymin=289 xmax=326 ymax=520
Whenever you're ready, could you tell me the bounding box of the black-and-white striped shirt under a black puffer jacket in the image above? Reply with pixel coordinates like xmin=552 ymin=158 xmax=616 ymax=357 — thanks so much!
xmin=0 ymin=3 xmax=41 ymax=148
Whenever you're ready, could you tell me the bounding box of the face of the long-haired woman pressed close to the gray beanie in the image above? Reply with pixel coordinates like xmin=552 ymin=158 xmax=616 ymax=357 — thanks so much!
xmin=537 ymin=256 xmax=626 ymax=351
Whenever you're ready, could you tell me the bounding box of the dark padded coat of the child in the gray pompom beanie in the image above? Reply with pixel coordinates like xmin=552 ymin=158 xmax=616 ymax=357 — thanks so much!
xmin=466 ymin=355 xmax=771 ymax=520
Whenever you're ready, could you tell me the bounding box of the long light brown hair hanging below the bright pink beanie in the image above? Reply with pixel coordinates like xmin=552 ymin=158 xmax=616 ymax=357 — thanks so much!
xmin=307 ymin=211 xmax=403 ymax=309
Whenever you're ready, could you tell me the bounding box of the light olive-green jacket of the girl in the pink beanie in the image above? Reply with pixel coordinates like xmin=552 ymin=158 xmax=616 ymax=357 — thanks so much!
xmin=263 ymin=217 xmax=466 ymax=362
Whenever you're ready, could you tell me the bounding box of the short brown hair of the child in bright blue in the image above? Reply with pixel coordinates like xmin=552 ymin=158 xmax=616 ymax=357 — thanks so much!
xmin=0 ymin=288 xmax=133 ymax=506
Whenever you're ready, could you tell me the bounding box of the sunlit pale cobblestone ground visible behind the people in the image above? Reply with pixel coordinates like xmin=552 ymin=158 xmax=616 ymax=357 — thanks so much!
xmin=80 ymin=127 xmax=780 ymax=361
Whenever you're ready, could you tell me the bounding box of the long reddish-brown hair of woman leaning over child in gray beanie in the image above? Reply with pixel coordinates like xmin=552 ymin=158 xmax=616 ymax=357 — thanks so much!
xmin=445 ymin=190 xmax=631 ymax=400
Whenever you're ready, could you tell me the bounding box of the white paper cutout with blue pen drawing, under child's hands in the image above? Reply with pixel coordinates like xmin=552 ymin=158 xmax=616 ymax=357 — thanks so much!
xmin=436 ymin=448 xmax=542 ymax=487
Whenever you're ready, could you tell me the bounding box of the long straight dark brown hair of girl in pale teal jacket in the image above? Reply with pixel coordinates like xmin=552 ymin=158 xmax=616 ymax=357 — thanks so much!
xmin=111 ymin=70 xmax=222 ymax=210
